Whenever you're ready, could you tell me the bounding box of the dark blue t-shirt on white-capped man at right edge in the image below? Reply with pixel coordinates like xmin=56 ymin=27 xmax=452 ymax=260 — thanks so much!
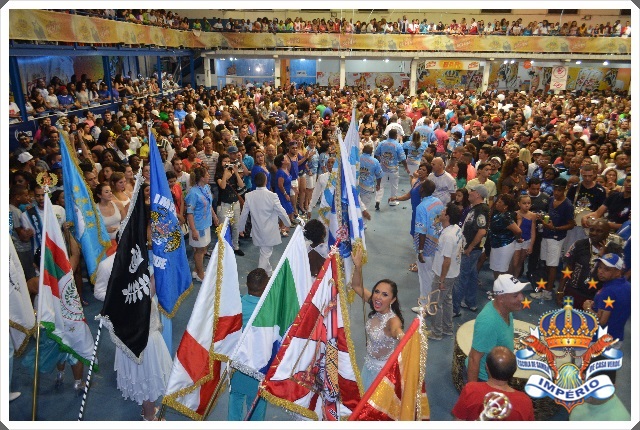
xmin=593 ymin=278 xmax=631 ymax=341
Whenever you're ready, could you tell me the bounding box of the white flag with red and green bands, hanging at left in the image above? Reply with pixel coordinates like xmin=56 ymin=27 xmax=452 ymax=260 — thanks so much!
xmin=38 ymin=193 xmax=93 ymax=365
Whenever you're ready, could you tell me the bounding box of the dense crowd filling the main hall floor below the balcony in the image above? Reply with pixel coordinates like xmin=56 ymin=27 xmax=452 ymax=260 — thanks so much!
xmin=9 ymin=75 xmax=631 ymax=419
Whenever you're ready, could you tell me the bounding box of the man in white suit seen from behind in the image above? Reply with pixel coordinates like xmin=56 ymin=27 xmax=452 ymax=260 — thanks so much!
xmin=238 ymin=172 xmax=291 ymax=276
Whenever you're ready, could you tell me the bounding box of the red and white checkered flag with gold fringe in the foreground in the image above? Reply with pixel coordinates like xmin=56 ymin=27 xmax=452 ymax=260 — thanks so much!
xmin=260 ymin=256 xmax=362 ymax=421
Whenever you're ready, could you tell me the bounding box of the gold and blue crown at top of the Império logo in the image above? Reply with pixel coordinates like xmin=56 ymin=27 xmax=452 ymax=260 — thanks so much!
xmin=538 ymin=297 xmax=598 ymax=349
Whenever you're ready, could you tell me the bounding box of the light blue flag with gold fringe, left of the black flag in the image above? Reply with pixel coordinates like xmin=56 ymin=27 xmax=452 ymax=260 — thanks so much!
xmin=60 ymin=134 xmax=112 ymax=284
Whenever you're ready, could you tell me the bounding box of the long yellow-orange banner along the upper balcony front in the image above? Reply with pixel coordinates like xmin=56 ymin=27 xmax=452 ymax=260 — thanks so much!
xmin=9 ymin=9 xmax=631 ymax=55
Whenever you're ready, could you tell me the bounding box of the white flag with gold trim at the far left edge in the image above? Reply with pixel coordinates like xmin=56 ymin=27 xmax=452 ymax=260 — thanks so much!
xmin=9 ymin=240 xmax=36 ymax=355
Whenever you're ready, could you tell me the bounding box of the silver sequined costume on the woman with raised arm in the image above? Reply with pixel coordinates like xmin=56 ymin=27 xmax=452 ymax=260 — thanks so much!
xmin=362 ymin=311 xmax=398 ymax=390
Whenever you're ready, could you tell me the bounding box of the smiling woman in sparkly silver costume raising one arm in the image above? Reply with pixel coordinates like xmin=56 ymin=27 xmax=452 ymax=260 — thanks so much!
xmin=351 ymin=249 xmax=404 ymax=390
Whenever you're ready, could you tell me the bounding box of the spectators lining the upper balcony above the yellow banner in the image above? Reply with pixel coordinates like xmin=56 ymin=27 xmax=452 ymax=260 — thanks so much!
xmin=51 ymin=9 xmax=631 ymax=37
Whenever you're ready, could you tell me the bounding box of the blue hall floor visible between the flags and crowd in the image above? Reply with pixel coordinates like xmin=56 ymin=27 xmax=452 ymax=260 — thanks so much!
xmin=9 ymin=177 xmax=631 ymax=421
